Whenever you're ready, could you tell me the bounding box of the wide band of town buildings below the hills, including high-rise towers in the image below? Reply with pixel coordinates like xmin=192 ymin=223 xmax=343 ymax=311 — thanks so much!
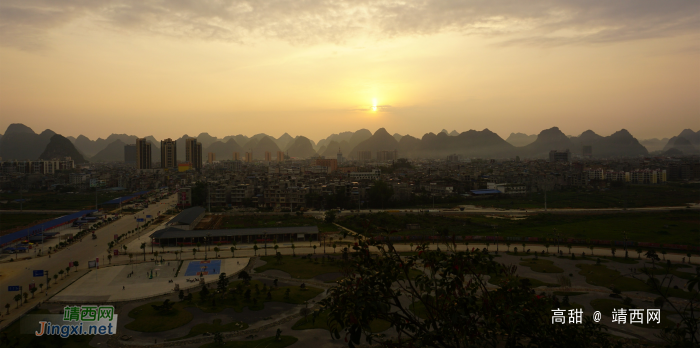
xmin=0 ymin=138 xmax=700 ymax=210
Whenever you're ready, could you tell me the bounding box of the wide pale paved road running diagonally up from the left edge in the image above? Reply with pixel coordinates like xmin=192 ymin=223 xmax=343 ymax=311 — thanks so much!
xmin=0 ymin=195 xmax=176 ymax=328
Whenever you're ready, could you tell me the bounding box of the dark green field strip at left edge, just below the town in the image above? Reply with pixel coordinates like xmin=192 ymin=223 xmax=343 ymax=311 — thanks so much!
xmin=0 ymin=191 xmax=129 ymax=210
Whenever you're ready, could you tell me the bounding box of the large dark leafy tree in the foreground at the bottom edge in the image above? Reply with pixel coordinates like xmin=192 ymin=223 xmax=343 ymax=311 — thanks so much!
xmin=314 ymin=240 xmax=608 ymax=348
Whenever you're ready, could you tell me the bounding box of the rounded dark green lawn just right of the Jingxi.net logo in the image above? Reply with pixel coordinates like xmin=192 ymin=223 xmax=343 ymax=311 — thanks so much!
xmin=124 ymin=301 xmax=193 ymax=332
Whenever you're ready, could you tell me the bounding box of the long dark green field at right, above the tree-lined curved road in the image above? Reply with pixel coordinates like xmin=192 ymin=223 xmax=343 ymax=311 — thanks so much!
xmin=338 ymin=209 xmax=700 ymax=245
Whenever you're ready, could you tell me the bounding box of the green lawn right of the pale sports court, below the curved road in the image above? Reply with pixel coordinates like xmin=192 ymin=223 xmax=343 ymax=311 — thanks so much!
xmin=255 ymin=255 xmax=341 ymax=279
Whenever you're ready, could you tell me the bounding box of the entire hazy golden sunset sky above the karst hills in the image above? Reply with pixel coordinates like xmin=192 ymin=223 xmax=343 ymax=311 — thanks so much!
xmin=0 ymin=0 xmax=700 ymax=141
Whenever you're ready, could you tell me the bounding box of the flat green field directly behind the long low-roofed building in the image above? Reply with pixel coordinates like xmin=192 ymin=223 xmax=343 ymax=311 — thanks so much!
xmin=221 ymin=214 xmax=338 ymax=232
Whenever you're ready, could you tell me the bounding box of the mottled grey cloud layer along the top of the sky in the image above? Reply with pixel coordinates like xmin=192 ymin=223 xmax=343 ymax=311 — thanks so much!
xmin=0 ymin=0 xmax=700 ymax=50
